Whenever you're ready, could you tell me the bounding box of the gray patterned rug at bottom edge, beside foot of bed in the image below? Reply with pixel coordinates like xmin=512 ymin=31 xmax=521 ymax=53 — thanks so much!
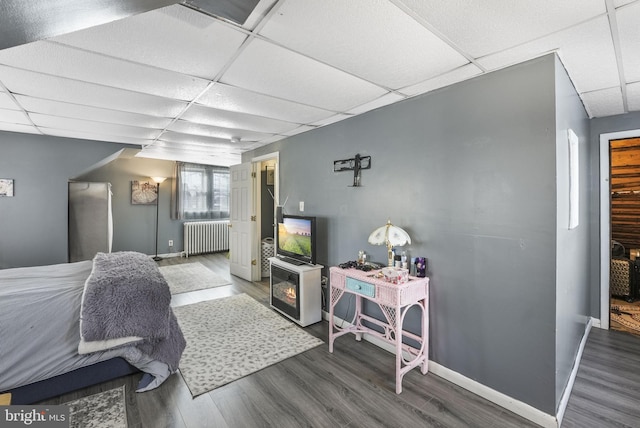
xmin=64 ymin=385 xmax=127 ymax=428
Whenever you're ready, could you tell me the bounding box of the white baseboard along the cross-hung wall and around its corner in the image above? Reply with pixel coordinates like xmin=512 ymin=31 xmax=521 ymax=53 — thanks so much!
xmin=322 ymin=311 xmax=594 ymax=428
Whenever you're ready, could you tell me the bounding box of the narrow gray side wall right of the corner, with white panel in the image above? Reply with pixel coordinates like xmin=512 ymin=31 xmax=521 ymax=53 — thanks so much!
xmin=555 ymin=58 xmax=597 ymax=404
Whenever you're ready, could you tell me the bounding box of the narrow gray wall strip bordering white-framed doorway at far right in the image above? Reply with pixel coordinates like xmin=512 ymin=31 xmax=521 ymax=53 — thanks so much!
xmin=589 ymin=112 xmax=640 ymax=318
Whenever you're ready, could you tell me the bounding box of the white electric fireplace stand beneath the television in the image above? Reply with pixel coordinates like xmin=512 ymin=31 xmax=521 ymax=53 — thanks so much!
xmin=269 ymin=257 xmax=324 ymax=327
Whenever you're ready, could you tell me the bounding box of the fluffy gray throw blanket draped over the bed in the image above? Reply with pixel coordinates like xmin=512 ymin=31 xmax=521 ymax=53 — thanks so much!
xmin=80 ymin=251 xmax=186 ymax=373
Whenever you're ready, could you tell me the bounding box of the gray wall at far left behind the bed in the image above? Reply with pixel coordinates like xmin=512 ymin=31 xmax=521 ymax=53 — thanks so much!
xmin=0 ymin=132 xmax=127 ymax=268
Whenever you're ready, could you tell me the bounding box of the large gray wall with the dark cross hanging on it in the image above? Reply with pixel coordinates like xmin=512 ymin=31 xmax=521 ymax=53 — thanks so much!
xmin=243 ymin=56 xmax=588 ymax=414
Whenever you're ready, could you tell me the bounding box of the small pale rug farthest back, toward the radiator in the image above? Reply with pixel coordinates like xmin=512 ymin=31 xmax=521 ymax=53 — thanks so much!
xmin=159 ymin=262 xmax=231 ymax=294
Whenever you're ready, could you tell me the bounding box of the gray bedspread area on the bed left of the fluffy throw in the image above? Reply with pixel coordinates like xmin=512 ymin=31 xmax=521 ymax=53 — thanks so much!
xmin=0 ymin=261 xmax=125 ymax=391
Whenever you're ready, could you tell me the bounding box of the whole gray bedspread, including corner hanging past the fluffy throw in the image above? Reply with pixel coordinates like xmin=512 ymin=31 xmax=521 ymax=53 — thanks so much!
xmin=0 ymin=253 xmax=184 ymax=391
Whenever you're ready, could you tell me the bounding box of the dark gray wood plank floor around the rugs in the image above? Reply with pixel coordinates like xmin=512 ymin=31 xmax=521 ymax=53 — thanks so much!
xmin=38 ymin=254 xmax=640 ymax=428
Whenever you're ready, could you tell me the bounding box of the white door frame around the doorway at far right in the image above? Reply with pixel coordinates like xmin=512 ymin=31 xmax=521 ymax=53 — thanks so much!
xmin=600 ymin=129 xmax=640 ymax=330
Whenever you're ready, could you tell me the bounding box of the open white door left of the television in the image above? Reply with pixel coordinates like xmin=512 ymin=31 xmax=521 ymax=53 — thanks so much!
xmin=229 ymin=162 xmax=257 ymax=281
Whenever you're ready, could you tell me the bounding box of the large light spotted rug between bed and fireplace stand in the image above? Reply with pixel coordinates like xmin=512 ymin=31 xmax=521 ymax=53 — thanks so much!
xmin=173 ymin=294 xmax=324 ymax=397
